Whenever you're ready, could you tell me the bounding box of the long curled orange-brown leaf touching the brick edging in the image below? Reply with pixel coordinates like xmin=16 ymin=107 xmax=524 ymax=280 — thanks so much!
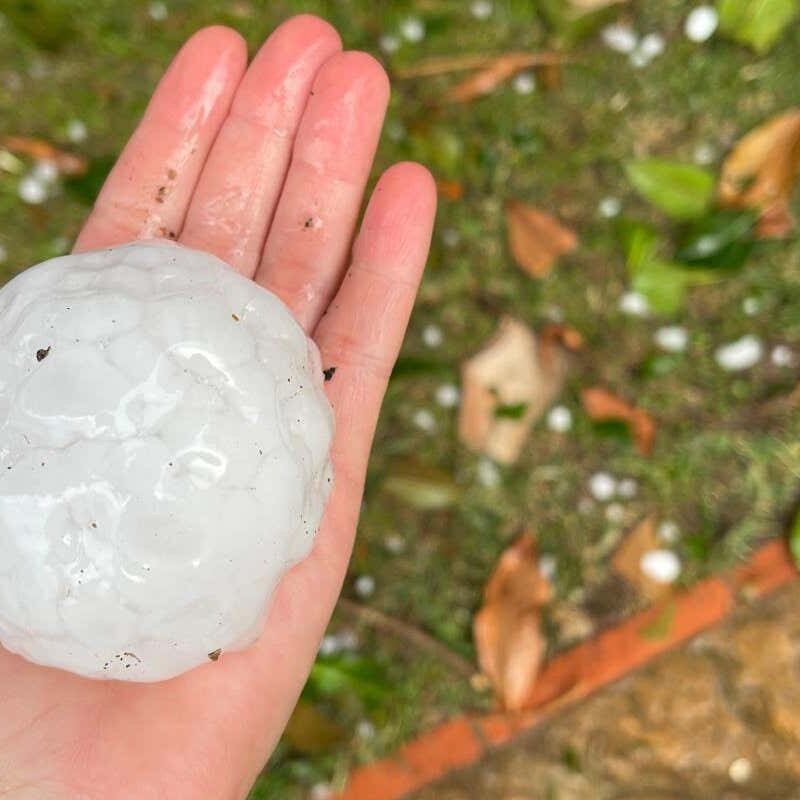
xmin=473 ymin=533 xmax=552 ymax=711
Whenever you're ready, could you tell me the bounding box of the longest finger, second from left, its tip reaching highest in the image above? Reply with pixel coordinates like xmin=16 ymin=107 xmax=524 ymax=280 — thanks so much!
xmin=181 ymin=15 xmax=341 ymax=277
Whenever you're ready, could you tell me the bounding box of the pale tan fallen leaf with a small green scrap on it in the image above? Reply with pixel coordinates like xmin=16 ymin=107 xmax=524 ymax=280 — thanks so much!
xmin=458 ymin=317 xmax=567 ymax=464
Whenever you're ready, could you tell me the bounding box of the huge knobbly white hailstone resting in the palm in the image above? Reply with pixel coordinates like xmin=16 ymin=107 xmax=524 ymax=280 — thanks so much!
xmin=0 ymin=242 xmax=333 ymax=681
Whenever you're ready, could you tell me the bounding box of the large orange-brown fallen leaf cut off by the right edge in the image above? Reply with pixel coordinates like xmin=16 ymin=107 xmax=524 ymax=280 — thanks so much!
xmin=719 ymin=109 xmax=800 ymax=238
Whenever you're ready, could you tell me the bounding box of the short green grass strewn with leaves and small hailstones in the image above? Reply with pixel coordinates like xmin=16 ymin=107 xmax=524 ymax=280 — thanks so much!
xmin=0 ymin=0 xmax=800 ymax=800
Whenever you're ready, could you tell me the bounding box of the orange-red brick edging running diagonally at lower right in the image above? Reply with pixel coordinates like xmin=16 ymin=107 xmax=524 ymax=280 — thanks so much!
xmin=337 ymin=539 xmax=798 ymax=800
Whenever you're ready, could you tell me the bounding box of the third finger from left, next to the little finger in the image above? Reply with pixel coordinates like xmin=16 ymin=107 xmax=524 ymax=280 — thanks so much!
xmin=256 ymin=52 xmax=389 ymax=330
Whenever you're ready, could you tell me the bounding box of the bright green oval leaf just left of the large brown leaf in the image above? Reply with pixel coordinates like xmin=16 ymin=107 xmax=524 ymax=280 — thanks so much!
xmin=625 ymin=158 xmax=714 ymax=219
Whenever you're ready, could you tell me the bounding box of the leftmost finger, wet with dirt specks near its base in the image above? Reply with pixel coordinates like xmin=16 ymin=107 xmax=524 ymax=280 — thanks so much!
xmin=75 ymin=26 xmax=247 ymax=250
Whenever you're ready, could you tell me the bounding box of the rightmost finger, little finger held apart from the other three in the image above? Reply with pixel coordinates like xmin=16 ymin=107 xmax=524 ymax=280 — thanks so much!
xmin=314 ymin=163 xmax=436 ymax=496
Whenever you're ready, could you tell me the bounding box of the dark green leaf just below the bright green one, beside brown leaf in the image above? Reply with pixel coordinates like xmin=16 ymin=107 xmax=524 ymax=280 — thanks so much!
xmin=675 ymin=210 xmax=757 ymax=270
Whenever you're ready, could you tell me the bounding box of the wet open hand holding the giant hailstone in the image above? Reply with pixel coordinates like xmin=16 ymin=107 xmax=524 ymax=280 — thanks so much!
xmin=0 ymin=16 xmax=436 ymax=800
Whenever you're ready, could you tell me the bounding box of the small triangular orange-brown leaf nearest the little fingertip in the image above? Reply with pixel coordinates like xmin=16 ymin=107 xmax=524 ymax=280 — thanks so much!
xmin=506 ymin=200 xmax=578 ymax=278
